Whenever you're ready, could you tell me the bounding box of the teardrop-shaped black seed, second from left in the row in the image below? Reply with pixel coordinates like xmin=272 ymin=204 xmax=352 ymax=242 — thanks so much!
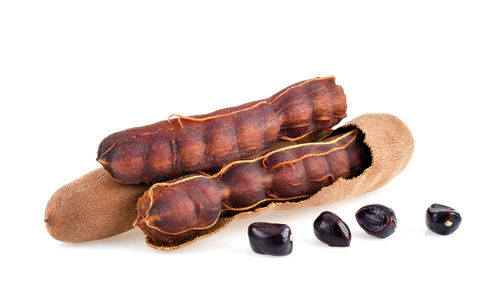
xmin=313 ymin=211 xmax=351 ymax=246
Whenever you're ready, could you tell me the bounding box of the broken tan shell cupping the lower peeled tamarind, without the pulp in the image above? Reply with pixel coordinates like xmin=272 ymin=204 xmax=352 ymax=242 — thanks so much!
xmin=136 ymin=114 xmax=414 ymax=249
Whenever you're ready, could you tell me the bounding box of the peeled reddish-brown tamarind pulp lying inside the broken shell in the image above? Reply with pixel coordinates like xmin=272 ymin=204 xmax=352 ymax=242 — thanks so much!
xmin=136 ymin=129 xmax=370 ymax=242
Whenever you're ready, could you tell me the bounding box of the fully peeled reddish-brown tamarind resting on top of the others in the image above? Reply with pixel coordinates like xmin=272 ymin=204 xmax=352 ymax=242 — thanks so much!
xmin=97 ymin=76 xmax=347 ymax=184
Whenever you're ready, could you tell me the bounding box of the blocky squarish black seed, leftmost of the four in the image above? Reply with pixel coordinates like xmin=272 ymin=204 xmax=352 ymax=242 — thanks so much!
xmin=248 ymin=222 xmax=293 ymax=256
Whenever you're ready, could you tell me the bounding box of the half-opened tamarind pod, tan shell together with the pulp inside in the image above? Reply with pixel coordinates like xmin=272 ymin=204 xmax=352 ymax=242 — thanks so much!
xmin=135 ymin=114 xmax=414 ymax=249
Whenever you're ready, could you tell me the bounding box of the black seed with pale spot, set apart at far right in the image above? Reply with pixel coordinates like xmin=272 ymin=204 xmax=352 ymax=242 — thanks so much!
xmin=425 ymin=203 xmax=462 ymax=235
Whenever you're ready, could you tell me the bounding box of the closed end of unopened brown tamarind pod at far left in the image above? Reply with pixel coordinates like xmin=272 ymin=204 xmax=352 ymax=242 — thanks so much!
xmin=44 ymin=168 xmax=148 ymax=242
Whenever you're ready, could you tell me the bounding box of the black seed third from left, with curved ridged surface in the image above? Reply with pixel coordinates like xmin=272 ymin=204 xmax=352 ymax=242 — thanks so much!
xmin=356 ymin=204 xmax=398 ymax=238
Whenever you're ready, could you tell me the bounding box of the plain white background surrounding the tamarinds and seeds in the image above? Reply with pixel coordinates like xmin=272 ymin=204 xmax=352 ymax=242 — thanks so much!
xmin=0 ymin=0 xmax=500 ymax=301
